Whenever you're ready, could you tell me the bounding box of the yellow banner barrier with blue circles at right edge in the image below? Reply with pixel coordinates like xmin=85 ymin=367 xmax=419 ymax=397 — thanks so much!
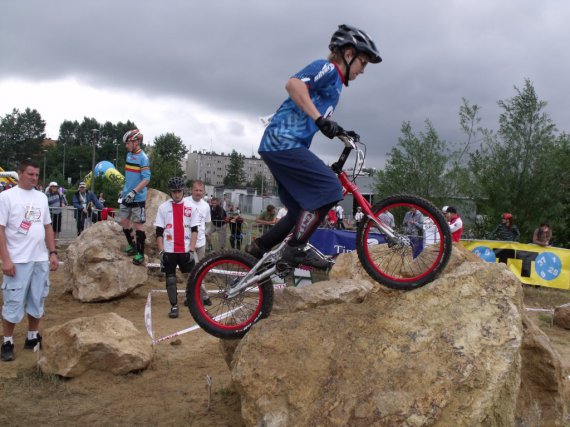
xmin=461 ymin=240 xmax=570 ymax=289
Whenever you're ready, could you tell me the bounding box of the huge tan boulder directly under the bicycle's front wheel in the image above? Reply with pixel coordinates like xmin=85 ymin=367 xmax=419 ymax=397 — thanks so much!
xmin=226 ymin=247 xmax=523 ymax=426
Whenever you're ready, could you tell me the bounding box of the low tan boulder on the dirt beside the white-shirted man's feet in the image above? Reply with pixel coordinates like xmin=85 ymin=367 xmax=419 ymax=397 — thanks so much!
xmin=38 ymin=313 xmax=153 ymax=378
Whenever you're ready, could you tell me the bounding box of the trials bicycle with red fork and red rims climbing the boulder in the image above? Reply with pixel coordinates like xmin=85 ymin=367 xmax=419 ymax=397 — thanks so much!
xmin=186 ymin=132 xmax=452 ymax=339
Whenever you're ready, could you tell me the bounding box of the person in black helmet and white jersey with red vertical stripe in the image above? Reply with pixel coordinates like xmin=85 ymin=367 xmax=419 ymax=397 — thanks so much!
xmin=154 ymin=176 xmax=200 ymax=319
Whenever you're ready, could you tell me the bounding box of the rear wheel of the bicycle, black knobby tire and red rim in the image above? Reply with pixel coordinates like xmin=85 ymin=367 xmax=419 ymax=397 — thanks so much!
xmin=186 ymin=250 xmax=274 ymax=339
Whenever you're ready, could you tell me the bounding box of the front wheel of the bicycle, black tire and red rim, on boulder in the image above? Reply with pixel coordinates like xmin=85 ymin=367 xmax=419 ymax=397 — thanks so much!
xmin=356 ymin=194 xmax=452 ymax=290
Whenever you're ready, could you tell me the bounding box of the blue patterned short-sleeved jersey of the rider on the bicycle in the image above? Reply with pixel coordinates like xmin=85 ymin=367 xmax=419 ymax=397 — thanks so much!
xmin=259 ymin=59 xmax=342 ymax=152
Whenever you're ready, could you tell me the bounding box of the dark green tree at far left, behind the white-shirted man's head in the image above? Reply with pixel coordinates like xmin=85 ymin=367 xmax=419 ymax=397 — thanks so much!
xmin=0 ymin=108 xmax=46 ymax=170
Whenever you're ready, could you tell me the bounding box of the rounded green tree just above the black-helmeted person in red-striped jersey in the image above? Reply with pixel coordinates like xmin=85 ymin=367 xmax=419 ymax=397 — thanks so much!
xmin=147 ymin=133 xmax=188 ymax=192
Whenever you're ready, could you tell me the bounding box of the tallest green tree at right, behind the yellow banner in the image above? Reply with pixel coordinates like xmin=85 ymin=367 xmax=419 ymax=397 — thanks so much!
xmin=469 ymin=80 xmax=563 ymax=242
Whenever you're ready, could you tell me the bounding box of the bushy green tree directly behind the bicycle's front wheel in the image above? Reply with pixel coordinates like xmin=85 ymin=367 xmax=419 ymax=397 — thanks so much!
xmin=375 ymin=120 xmax=448 ymax=204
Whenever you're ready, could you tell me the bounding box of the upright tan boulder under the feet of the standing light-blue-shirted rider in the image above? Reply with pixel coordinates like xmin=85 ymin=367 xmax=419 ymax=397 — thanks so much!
xmin=63 ymin=221 xmax=148 ymax=302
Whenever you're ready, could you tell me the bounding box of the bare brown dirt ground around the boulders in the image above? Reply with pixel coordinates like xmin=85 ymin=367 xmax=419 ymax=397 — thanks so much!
xmin=0 ymin=269 xmax=570 ymax=427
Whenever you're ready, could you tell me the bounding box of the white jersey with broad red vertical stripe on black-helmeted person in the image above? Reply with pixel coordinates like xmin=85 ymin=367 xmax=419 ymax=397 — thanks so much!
xmin=154 ymin=199 xmax=200 ymax=253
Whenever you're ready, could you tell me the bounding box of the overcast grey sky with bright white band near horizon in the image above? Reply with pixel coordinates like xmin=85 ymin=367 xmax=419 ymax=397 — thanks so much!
xmin=0 ymin=0 xmax=570 ymax=167
